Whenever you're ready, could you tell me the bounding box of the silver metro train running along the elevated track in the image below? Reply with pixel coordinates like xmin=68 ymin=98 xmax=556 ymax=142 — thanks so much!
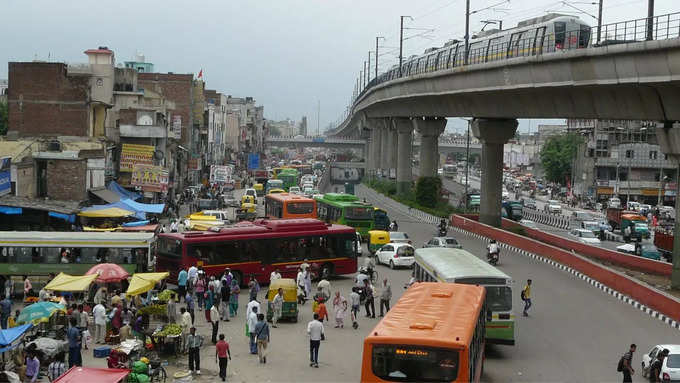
xmin=378 ymin=13 xmax=591 ymax=82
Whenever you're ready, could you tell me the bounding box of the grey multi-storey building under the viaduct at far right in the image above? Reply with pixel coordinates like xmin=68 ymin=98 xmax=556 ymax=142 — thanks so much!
xmin=567 ymin=119 xmax=677 ymax=205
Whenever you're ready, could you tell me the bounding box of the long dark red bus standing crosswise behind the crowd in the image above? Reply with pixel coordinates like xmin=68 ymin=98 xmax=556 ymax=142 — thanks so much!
xmin=156 ymin=218 xmax=357 ymax=285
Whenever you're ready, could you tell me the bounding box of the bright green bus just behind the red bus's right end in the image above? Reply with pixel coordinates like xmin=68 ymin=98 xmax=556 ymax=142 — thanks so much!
xmin=315 ymin=193 xmax=373 ymax=238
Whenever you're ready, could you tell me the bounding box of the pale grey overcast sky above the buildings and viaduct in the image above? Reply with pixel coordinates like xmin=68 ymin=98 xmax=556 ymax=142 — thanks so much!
xmin=0 ymin=0 xmax=680 ymax=132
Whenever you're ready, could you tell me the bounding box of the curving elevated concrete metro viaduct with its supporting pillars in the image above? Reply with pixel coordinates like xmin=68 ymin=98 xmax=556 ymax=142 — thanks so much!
xmin=332 ymin=13 xmax=680 ymax=226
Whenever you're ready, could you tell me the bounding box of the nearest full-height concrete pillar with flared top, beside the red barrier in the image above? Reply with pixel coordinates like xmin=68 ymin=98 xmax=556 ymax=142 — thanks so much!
xmin=472 ymin=118 xmax=517 ymax=227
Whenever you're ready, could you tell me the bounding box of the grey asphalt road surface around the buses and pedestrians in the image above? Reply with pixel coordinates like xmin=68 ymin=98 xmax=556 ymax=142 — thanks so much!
xmin=83 ymin=186 xmax=680 ymax=382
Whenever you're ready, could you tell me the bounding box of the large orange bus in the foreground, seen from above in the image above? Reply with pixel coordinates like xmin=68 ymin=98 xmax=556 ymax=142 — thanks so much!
xmin=361 ymin=282 xmax=486 ymax=383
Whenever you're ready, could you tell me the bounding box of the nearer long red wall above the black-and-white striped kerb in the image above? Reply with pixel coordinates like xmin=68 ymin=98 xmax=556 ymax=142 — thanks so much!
xmin=451 ymin=215 xmax=680 ymax=322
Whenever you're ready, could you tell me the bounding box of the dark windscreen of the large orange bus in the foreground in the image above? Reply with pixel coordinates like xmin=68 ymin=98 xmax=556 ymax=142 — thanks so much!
xmin=373 ymin=344 xmax=458 ymax=382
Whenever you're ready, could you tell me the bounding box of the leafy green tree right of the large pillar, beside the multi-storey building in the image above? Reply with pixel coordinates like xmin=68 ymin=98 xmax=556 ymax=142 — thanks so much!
xmin=541 ymin=133 xmax=583 ymax=184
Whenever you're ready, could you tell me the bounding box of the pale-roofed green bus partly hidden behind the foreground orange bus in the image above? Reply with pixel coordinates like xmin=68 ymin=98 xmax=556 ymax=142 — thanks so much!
xmin=413 ymin=247 xmax=515 ymax=346
